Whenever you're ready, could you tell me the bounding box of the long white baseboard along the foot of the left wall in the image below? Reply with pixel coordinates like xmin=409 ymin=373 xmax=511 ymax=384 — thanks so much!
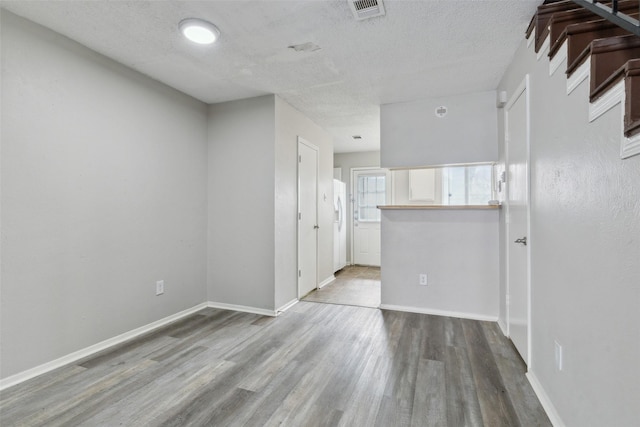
xmin=0 ymin=303 xmax=207 ymax=390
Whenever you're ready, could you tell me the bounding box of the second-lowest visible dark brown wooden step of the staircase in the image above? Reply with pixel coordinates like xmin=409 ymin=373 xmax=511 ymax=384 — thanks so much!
xmin=589 ymin=35 xmax=640 ymax=102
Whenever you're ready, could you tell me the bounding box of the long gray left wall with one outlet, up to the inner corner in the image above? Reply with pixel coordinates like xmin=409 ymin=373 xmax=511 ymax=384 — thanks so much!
xmin=0 ymin=11 xmax=207 ymax=377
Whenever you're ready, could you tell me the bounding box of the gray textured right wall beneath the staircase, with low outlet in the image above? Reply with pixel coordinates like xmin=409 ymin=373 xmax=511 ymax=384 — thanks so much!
xmin=499 ymin=42 xmax=640 ymax=426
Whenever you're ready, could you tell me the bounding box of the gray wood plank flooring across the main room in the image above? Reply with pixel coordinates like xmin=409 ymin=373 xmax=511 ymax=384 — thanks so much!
xmin=0 ymin=302 xmax=551 ymax=427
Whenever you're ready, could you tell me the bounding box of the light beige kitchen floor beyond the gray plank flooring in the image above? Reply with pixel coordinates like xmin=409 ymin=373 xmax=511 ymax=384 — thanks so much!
xmin=303 ymin=265 xmax=380 ymax=308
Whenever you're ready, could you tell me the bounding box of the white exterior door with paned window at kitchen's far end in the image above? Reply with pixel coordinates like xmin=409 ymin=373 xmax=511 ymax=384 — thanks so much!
xmin=351 ymin=169 xmax=389 ymax=266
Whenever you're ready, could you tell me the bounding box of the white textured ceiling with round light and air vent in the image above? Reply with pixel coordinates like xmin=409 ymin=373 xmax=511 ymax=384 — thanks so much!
xmin=1 ymin=0 xmax=542 ymax=152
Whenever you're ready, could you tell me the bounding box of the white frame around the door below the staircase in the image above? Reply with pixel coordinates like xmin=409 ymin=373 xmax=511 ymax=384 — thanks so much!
xmin=504 ymin=74 xmax=533 ymax=370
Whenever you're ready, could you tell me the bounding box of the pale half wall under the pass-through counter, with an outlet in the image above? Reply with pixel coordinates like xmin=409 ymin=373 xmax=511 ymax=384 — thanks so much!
xmin=381 ymin=210 xmax=499 ymax=319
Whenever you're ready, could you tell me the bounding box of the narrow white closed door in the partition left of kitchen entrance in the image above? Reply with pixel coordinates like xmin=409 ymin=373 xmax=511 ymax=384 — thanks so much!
xmin=298 ymin=138 xmax=318 ymax=298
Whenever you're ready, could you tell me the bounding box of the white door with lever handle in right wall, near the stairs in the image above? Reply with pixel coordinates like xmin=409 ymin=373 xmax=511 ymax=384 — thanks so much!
xmin=505 ymin=76 xmax=530 ymax=364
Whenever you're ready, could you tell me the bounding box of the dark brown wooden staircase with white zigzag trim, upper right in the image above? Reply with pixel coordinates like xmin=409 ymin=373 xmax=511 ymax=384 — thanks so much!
xmin=526 ymin=0 xmax=640 ymax=158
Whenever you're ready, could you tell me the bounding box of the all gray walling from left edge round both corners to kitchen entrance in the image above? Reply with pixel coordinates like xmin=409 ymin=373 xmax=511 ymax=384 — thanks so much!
xmin=0 ymin=11 xmax=333 ymax=384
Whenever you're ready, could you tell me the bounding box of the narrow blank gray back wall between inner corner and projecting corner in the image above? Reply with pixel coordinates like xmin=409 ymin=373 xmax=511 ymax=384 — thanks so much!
xmin=207 ymin=95 xmax=275 ymax=310
